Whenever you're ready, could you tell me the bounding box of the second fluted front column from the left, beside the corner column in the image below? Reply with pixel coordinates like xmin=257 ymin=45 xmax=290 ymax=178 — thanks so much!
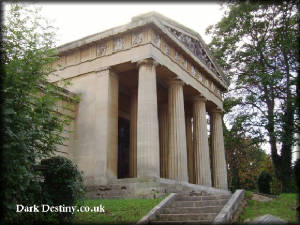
xmin=168 ymin=80 xmax=188 ymax=181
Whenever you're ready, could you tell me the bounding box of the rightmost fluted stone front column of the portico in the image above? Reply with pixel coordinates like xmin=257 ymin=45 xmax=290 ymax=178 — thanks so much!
xmin=211 ymin=109 xmax=228 ymax=190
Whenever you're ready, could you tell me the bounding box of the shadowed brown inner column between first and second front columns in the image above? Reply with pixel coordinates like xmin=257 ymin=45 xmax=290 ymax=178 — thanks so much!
xmin=158 ymin=104 xmax=169 ymax=178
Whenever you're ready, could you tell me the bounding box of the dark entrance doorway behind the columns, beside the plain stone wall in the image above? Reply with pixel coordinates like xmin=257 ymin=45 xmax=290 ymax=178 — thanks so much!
xmin=118 ymin=117 xmax=130 ymax=179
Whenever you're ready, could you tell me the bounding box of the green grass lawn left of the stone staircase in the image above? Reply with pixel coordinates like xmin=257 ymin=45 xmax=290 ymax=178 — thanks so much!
xmin=74 ymin=195 xmax=167 ymax=224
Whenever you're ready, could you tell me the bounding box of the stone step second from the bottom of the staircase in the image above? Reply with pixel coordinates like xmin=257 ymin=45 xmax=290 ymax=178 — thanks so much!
xmin=162 ymin=206 xmax=223 ymax=214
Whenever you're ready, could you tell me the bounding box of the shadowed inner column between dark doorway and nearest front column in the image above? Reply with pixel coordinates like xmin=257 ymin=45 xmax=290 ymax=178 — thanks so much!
xmin=129 ymin=90 xmax=137 ymax=177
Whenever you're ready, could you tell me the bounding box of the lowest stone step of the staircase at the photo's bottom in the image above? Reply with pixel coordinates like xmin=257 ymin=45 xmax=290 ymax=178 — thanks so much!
xmin=156 ymin=213 xmax=217 ymax=221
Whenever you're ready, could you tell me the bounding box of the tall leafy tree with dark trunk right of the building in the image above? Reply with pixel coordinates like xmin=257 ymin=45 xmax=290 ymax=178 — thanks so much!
xmin=207 ymin=1 xmax=299 ymax=192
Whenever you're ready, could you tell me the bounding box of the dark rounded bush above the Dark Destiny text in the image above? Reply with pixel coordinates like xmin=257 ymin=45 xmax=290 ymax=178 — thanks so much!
xmin=41 ymin=156 xmax=84 ymax=221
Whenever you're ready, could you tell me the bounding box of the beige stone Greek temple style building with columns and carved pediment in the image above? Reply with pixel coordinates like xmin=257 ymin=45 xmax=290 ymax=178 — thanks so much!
xmin=50 ymin=12 xmax=228 ymax=195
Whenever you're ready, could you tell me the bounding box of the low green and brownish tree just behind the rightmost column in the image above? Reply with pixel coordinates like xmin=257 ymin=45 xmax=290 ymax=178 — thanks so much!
xmin=223 ymin=98 xmax=267 ymax=191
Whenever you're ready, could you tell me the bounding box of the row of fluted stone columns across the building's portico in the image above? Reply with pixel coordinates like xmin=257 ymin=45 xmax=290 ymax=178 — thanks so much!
xmin=125 ymin=59 xmax=227 ymax=189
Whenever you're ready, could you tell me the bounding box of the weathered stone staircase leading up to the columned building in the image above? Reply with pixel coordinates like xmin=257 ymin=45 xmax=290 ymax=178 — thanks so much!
xmin=150 ymin=193 xmax=231 ymax=224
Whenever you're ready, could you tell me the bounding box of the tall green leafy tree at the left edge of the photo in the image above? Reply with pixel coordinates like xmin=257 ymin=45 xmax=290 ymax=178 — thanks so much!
xmin=1 ymin=4 xmax=74 ymax=222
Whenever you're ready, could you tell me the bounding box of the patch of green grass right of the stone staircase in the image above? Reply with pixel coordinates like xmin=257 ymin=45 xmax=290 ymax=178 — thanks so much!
xmin=239 ymin=192 xmax=299 ymax=224
